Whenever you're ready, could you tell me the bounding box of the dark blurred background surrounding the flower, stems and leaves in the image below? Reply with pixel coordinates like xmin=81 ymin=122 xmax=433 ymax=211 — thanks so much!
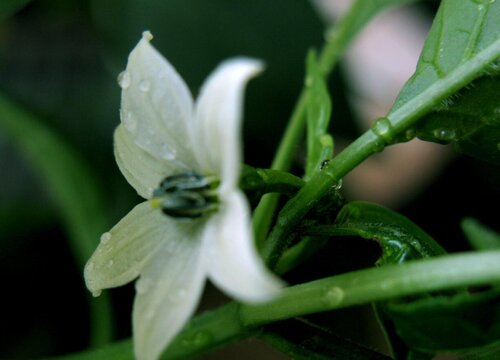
xmin=0 ymin=0 xmax=500 ymax=359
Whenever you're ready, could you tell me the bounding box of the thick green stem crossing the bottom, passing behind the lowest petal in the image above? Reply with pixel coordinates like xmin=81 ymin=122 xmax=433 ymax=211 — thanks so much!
xmin=57 ymin=250 xmax=500 ymax=360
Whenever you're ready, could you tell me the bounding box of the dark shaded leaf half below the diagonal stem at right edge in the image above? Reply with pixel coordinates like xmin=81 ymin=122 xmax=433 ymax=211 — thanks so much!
xmin=417 ymin=76 xmax=500 ymax=164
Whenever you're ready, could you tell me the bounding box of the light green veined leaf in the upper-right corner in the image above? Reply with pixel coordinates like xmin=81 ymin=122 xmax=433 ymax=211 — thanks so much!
xmin=386 ymin=0 xmax=500 ymax=141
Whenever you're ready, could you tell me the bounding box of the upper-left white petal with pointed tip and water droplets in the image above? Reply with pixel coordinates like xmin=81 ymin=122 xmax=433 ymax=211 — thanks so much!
xmin=119 ymin=33 xmax=199 ymax=169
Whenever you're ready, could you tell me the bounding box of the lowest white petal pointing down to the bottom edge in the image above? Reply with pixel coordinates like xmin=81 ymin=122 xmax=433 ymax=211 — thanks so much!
xmin=133 ymin=222 xmax=206 ymax=360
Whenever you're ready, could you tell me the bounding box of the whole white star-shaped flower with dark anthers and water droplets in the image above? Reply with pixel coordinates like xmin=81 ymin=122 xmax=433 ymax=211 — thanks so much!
xmin=85 ymin=32 xmax=282 ymax=359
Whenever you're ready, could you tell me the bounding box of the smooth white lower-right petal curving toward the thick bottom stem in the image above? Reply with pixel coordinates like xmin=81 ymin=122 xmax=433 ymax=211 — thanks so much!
xmin=204 ymin=191 xmax=282 ymax=302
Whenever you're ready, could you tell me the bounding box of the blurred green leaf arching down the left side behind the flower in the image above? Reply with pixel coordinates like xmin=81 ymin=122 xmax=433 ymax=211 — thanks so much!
xmin=0 ymin=94 xmax=111 ymax=344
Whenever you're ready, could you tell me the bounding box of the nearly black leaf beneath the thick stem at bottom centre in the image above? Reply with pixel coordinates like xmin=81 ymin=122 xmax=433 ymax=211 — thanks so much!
xmin=259 ymin=319 xmax=390 ymax=360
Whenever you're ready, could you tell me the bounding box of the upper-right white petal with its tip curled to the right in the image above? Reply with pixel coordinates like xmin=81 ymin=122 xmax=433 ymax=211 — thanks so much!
xmin=193 ymin=58 xmax=262 ymax=187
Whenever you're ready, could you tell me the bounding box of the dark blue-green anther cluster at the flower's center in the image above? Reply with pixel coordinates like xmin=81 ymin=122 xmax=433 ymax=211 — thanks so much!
xmin=151 ymin=172 xmax=219 ymax=219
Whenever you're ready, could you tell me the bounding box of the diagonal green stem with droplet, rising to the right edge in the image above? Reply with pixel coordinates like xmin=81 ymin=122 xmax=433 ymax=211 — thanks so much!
xmin=262 ymin=40 xmax=500 ymax=268
